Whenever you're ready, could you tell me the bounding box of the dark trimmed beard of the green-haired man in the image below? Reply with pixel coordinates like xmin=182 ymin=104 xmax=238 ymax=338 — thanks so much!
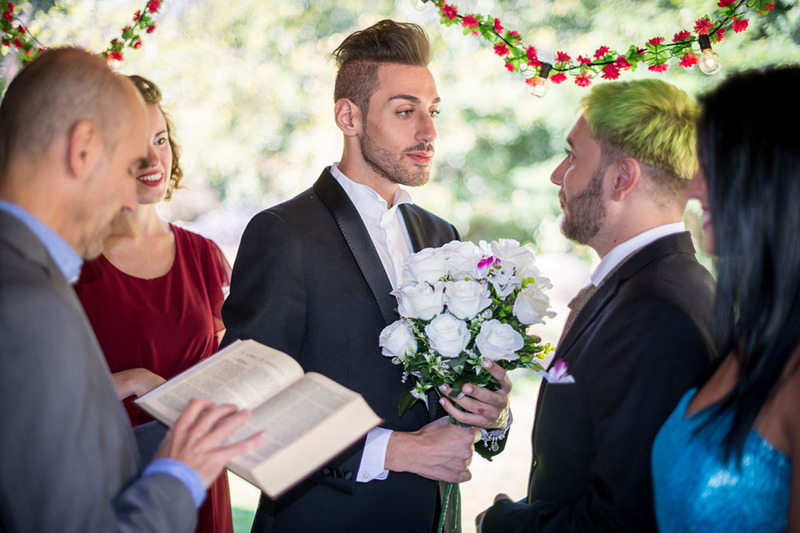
xmin=559 ymin=168 xmax=606 ymax=244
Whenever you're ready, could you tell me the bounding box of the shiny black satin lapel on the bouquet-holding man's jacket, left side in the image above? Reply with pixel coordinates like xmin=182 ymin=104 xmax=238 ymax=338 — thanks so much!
xmin=314 ymin=169 xmax=397 ymax=324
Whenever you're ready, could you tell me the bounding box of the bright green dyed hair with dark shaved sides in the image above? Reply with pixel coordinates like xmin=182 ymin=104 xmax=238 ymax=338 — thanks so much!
xmin=581 ymin=79 xmax=700 ymax=202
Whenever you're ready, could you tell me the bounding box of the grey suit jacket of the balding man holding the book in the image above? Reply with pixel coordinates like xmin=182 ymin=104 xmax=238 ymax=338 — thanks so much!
xmin=0 ymin=211 xmax=197 ymax=533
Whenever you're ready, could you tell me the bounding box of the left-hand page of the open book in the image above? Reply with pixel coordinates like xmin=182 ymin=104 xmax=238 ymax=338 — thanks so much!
xmin=136 ymin=340 xmax=303 ymax=422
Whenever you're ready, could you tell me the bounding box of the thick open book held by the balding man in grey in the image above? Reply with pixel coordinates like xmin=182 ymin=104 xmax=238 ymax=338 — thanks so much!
xmin=136 ymin=340 xmax=381 ymax=498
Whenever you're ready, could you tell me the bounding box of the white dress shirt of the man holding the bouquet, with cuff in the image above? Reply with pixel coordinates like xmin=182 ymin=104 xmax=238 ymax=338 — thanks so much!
xmin=331 ymin=163 xmax=413 ymax=483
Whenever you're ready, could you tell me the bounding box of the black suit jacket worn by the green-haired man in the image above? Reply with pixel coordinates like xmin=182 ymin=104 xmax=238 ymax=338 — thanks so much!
xmin=483 ymin=233 xmax=713 ymax=533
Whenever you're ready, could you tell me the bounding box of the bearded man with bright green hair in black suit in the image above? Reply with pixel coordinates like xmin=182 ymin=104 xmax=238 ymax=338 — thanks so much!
xmin=478 ymin=80 xmax=713 ymax=533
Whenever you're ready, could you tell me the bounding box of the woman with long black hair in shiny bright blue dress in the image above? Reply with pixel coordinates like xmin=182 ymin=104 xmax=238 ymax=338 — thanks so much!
xmin=652 ymin=66 xmax=800 ymax=533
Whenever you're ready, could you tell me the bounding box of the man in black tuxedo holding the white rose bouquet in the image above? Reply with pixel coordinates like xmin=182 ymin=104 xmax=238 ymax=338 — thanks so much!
xmin=222 ymin=20 xmax=511 ymax=533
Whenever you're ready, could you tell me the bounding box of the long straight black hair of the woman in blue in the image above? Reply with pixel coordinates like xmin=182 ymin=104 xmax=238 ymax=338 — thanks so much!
xmin=697 ymin=66 xmax=800 ymax=457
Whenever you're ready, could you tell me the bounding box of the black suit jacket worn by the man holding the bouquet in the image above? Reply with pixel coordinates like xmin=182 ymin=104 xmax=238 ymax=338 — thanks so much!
xmin=222 ymin=169 xmax=458 ymax=532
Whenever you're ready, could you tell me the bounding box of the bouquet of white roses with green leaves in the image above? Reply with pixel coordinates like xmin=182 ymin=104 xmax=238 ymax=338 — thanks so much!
xmin=380 ymin=239 xmax=555 ymax=415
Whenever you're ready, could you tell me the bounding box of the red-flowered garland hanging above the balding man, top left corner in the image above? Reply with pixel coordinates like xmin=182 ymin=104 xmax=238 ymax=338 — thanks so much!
xmin=0 ymin=0 xmax=161 ymax=65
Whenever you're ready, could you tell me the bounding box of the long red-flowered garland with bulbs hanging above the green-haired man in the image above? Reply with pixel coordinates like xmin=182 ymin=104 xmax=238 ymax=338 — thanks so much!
xmin=432 ymin=0 xmax=775 ymax=93
